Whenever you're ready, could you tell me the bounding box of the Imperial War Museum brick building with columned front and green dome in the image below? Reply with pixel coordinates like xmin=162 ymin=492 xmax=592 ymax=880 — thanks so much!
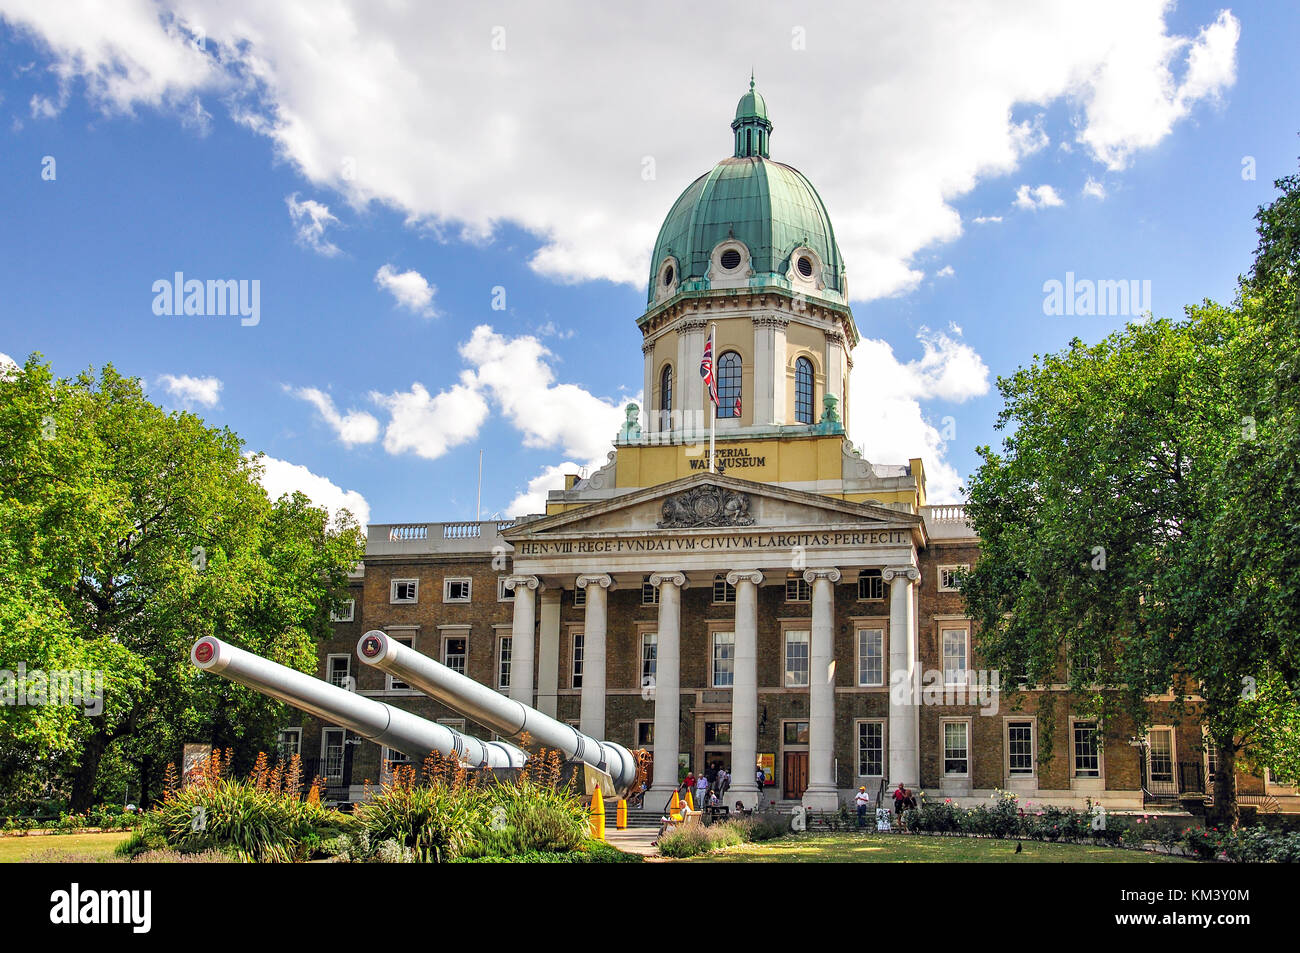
xmin=289 ymin=83 xmax=1295 ymax=810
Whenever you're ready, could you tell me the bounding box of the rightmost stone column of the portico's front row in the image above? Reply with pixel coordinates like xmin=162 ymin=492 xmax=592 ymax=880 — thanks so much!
xmin=880 ymin=566 xmax=920 ymax=789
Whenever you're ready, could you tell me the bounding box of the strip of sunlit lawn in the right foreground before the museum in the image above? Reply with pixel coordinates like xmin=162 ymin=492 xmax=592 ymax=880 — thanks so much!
xmin=677 ymin=833 xmax=1187 ymax=863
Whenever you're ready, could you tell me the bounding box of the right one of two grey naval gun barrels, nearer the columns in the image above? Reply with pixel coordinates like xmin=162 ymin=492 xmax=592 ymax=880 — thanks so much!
xmin=356 ymin=629 xmax=637 ymax=797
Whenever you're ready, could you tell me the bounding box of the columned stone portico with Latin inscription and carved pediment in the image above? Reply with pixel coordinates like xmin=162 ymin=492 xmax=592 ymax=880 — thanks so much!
xmin=504 ymin=473 xmax=924 ymax=810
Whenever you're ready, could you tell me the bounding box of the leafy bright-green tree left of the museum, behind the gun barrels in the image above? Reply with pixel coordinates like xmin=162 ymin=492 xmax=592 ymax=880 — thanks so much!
xmin=0 ymin=355 xmax=364 ymax=810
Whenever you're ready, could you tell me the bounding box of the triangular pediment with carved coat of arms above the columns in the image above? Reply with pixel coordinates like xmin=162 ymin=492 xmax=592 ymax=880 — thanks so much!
xmin=503 ymin=473 xmax=924 ymax=542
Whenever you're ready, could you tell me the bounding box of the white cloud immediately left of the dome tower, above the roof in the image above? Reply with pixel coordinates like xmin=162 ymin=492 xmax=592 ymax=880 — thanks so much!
xmin=460 ymin=325 xmax=624 ymax=463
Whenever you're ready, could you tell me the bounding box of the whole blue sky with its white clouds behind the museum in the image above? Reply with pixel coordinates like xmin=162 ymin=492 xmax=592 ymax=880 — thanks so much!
xmin=0 ymin=0 xmax=1300 ymax=523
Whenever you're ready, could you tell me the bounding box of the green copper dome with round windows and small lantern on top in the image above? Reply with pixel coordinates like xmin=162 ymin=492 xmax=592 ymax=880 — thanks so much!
xmin=649 ymin=81 xmax=846 ymax=304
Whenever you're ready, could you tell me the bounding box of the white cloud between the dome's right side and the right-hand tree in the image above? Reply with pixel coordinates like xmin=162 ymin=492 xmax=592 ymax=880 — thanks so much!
xmin=849 ymin=325 xmax=989 ymax=503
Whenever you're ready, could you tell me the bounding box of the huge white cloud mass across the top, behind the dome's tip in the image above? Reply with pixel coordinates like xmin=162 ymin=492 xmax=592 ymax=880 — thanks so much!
xmin=4 ymin=0 xmax=1240 ymax=300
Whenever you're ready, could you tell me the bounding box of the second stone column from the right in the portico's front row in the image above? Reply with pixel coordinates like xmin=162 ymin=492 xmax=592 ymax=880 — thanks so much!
xmin=803 ymin=569 xmax=840 ymax=811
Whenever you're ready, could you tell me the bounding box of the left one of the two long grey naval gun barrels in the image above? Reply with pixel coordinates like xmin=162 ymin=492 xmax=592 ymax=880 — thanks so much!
xmin=190 ymin=636 xmax=528 ymax=768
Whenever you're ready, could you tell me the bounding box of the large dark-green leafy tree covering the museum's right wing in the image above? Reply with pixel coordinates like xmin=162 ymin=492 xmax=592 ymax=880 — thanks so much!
xmin=963 ymin=165 xmax=1300 ymax=824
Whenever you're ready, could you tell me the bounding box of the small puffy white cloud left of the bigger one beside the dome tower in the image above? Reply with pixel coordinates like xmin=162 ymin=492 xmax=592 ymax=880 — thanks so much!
xmin=371 ymin=381 xmax=488 ymax=460
